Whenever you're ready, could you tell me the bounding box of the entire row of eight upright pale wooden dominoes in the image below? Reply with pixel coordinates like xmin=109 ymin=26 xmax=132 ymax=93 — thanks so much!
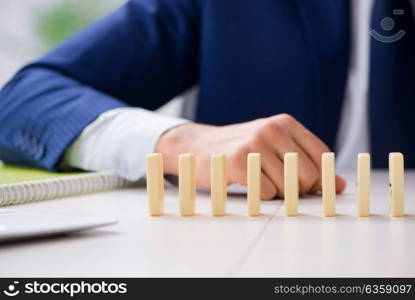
xmin=147 ymin=152 xmax=404 ymax=217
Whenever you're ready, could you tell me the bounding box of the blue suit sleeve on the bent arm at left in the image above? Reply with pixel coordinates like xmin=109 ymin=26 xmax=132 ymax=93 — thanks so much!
xmin=0 ymin=0 xmax=199 ymax=170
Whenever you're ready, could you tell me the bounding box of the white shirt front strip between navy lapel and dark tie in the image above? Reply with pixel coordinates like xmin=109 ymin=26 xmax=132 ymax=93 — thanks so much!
xmin=336 ymin=0 xmax=374 ymax=170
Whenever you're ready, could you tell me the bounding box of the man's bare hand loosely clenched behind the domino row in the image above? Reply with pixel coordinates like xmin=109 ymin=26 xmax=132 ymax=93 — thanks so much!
xmin=156 ymin=114 xmax=346 ymax=200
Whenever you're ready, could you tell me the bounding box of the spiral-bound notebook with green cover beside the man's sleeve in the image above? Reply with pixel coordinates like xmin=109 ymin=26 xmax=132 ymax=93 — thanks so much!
xmin=0 ymin=162 xmax=133 ymax=206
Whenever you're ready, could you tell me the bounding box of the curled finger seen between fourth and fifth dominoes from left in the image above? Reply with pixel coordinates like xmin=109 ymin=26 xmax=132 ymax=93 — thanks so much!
xmin=262 ymin=150 xmax=284 ymax=197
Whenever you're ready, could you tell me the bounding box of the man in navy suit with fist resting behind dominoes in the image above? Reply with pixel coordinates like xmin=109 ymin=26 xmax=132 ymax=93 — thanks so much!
xmin=0 ymin=0 xmax=415 ymax=199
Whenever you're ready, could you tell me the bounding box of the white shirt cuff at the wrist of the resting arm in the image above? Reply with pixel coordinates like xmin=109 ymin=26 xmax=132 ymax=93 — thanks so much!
xmin=61 ymin=108 xmax=189 ymax=180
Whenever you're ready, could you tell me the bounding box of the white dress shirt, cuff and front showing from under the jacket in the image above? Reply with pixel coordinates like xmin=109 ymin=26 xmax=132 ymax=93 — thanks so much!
xmin=63 ymin=0 xmax=412 ymax=180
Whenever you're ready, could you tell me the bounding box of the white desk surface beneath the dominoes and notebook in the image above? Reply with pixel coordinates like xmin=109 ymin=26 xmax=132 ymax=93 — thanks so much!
xmin=0 ymin=171 xmax=415 ymax=277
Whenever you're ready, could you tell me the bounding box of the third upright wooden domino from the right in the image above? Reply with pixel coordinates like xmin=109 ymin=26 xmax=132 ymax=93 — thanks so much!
xmin=321 ymin=152 xmax=336 ymax=217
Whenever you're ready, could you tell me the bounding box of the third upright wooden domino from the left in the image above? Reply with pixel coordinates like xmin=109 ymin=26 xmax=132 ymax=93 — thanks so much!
xmin=210 ymin=154 xmax=228 ymax=216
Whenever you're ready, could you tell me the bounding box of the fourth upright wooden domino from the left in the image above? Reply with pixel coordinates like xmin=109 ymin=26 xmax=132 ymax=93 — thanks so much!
xmin=247 ymin=153 xmax=261 ymax=216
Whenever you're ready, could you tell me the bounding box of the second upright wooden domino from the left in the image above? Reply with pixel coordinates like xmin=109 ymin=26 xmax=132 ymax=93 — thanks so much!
xmin=179 ymin=153 xmax=196 ymax=216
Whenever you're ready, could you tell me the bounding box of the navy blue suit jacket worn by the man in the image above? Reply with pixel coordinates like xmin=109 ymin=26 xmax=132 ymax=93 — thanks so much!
xmin=0 ymin=0 xmax=415 ymax=169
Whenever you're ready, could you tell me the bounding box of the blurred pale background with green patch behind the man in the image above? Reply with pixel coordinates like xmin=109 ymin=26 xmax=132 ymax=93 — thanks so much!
xmin=0 ymin=0 xmax=188 ymax=117
